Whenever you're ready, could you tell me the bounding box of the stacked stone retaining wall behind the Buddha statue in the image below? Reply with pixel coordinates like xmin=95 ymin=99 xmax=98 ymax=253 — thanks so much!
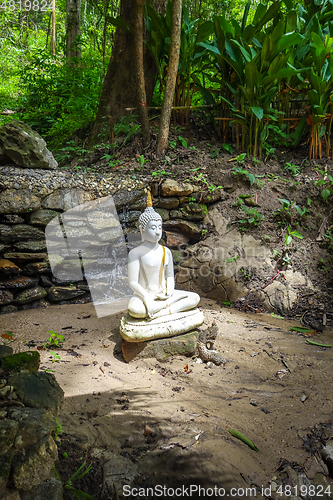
xmin=0 ymin=167 xmax=221 ymax=313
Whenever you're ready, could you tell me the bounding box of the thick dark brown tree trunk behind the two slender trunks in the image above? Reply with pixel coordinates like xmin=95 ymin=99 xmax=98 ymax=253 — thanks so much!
xmin=88 ymin=0 xmax=166 ymax=148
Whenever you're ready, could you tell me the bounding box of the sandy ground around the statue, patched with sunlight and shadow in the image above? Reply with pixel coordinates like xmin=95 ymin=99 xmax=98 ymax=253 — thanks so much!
xmin=0 ymin=299 xmax=333 ymax=498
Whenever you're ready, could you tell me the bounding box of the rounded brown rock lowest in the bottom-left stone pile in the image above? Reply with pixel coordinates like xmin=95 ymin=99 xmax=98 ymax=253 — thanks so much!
xmin=12 ymin=436 xmax=58 ymax=490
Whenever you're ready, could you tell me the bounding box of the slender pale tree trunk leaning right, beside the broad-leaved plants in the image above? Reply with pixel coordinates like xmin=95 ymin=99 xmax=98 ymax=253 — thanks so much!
xmin=157 ymin=0 xmax=182 ymax=158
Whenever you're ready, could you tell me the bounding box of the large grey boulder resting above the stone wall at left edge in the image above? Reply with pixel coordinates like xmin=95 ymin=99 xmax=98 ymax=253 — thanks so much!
xmin=0 ymin=120 xmax=58 ymax=170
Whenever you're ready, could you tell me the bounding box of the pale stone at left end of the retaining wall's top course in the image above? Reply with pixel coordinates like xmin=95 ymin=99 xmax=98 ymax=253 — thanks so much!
xmin=0 ymin=189 xmax=40 ymax=215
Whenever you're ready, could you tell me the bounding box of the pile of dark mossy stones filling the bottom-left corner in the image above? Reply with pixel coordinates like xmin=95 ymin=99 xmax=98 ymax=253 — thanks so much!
xmin=0 ymin=346 xmax=64 ymax=500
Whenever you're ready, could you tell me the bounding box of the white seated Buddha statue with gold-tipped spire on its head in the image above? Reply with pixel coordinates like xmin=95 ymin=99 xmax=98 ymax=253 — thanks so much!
xmin=120 ymin=193 xmax=204 ymax=342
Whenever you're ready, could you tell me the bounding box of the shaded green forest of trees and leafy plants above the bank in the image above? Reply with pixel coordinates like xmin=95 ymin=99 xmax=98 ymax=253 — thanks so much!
xmin=0 ymin=0 xmax=333 ymax=167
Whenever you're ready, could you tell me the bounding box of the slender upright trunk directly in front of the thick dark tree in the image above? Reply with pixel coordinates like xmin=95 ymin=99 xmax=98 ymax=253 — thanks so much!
xmin=134 ymin=0 xmax=150 ymax=148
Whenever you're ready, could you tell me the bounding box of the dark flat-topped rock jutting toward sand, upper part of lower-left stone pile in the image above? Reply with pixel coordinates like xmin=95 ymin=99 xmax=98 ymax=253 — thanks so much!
xmin=8 ymin=372 xmax=64 ymax=416
